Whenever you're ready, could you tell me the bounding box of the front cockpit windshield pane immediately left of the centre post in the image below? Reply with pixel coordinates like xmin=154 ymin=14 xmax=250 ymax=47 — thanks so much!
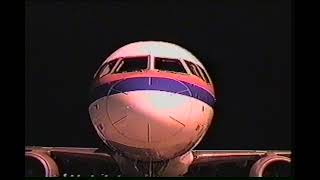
xmin=115 ymin=56 xmax=149 ymax=73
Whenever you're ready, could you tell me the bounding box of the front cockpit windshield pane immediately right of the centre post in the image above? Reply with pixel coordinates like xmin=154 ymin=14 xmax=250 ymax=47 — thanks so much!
xmin=154 ymin=57 xmax=187 ymax=73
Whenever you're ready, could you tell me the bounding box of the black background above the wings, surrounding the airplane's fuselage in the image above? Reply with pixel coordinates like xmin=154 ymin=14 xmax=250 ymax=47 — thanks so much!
xmin=25 ymin=0 xmax=292 ymax=149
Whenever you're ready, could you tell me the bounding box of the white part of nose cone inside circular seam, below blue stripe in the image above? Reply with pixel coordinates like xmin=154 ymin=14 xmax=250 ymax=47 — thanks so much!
xmin=106 ymin=90 xmax=191 ymax=143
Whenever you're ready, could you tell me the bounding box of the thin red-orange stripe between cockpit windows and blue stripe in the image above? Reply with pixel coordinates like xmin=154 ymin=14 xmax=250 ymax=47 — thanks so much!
xmin=94 ymin=70 xmax=214 ymax=95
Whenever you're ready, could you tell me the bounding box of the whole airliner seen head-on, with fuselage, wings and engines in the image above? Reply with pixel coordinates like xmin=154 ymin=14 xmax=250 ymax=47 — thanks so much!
xmin=25 ymin=41 xmax=291 ymax=177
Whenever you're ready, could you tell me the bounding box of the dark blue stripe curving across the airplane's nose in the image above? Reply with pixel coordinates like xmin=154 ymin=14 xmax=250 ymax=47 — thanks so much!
xmin=91 ymin=77 xmax=215 ymax=107
